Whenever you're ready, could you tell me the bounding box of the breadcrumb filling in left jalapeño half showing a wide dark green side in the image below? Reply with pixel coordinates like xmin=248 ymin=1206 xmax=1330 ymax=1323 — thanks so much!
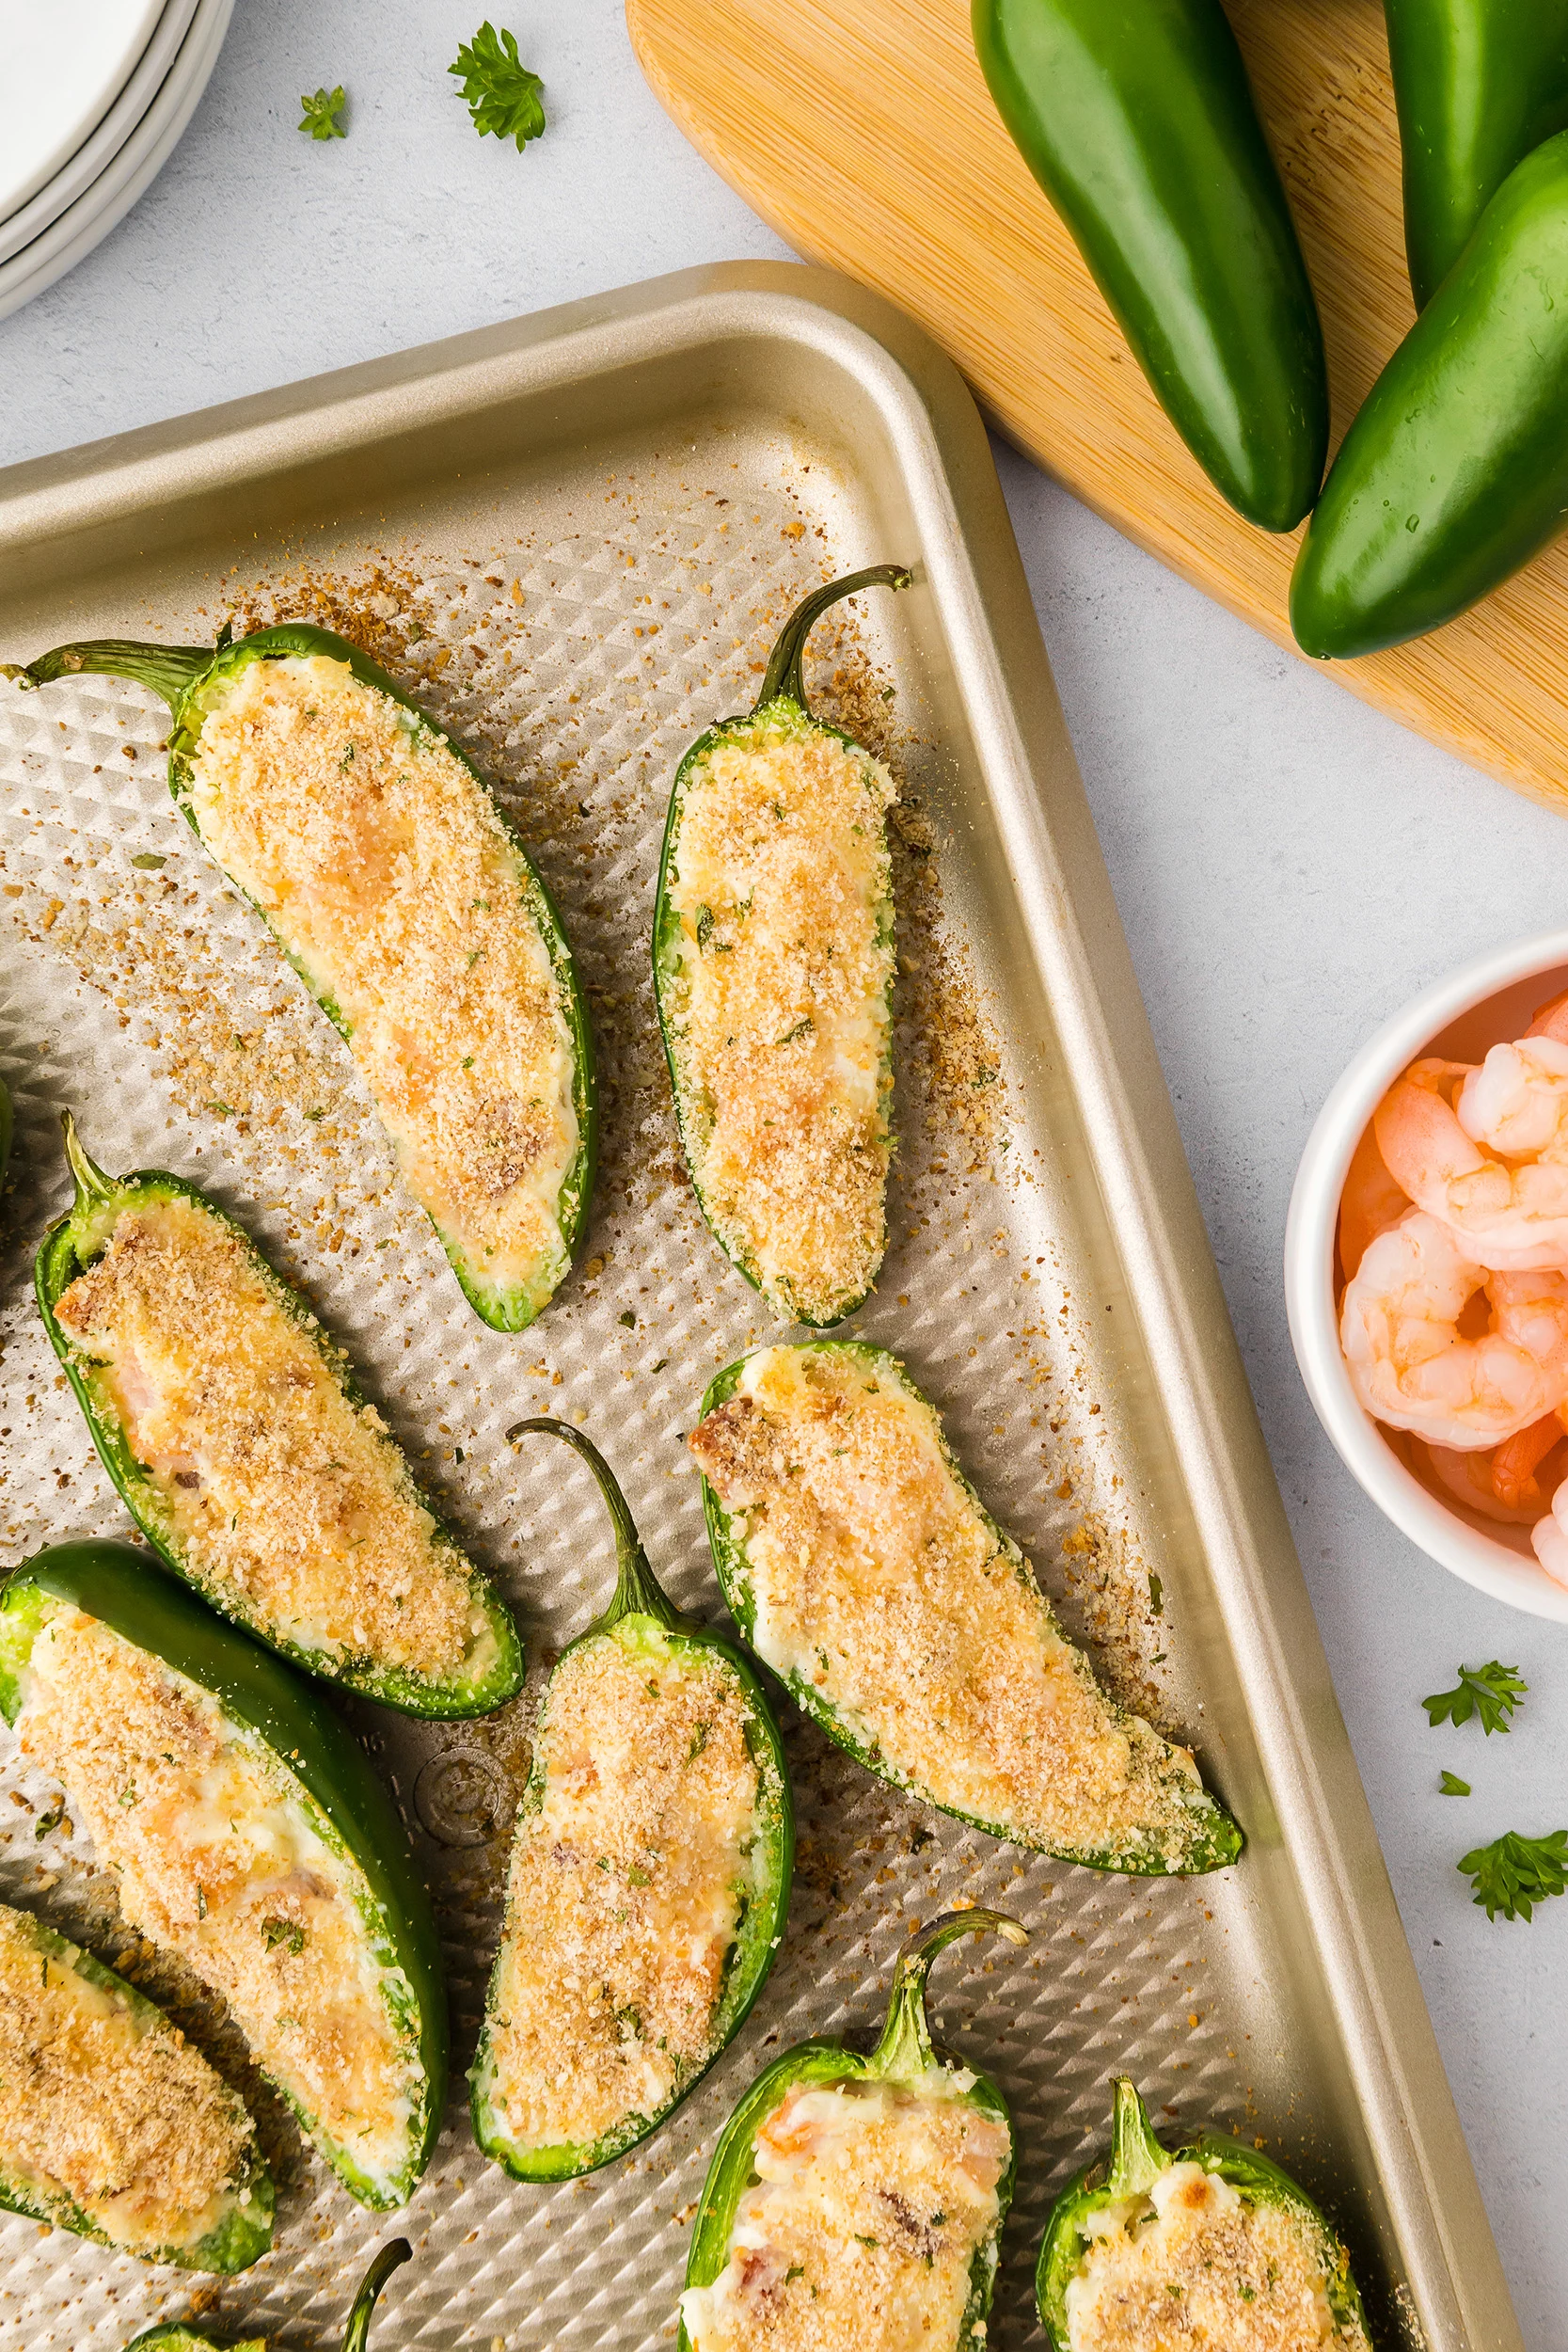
xmin=16 ymin=1607 xmax=420 ymax=2181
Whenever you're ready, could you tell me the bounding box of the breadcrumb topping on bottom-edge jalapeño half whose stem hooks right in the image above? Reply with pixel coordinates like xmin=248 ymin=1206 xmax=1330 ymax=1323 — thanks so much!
xmin=682 ymin=2068 xmax=1011 ymax=2352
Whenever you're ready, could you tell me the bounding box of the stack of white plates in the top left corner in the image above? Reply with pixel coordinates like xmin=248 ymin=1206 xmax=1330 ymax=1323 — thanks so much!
xmin=0 ymin=0 xmax=235 ymax=318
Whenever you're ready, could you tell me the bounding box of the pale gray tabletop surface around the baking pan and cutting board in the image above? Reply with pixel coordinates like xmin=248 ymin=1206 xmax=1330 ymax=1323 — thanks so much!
xmin=0 ymin=0 xmax=1568 ymax=2352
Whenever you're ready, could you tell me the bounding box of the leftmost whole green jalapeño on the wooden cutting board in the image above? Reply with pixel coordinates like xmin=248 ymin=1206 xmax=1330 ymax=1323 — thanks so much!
xmin=974 ymin=0 xmax=1328 ymax=532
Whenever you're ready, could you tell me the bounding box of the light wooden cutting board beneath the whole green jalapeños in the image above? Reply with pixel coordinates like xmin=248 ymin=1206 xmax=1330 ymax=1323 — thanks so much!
xmin=626 ymin=0 xmax=1568 ymax=809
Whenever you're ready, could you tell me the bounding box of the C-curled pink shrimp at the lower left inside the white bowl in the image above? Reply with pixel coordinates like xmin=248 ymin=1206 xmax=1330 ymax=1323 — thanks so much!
xmin=1340 ymin=1209 xmax=1568 ymax=1449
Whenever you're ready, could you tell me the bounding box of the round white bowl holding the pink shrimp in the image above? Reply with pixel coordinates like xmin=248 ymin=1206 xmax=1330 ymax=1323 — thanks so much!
xmin=1286 ymin=931 xmax=1568 ymax=1626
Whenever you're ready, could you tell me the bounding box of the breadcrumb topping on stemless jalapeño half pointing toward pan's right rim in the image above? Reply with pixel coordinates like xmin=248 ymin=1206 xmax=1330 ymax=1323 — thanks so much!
xmin=691 ymin=1345 xmax=1201 ymax=1861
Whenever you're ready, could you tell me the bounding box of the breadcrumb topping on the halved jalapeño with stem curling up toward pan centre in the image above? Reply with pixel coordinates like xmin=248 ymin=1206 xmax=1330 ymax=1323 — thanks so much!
xmin=489 ymin=1626 xmax=764 ymax=2148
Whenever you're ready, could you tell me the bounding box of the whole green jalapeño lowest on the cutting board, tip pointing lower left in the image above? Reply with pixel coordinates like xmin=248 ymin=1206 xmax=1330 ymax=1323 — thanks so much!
xmin=1291 ymin=132 xmax=1568 ymax=661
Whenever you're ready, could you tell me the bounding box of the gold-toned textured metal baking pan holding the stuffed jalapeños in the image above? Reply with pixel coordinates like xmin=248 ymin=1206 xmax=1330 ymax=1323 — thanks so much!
xmin=0 ymin=271 xmax=1516 ymax=2352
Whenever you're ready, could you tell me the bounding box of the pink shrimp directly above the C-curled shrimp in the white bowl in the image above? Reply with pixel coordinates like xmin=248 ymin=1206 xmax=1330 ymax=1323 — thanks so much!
xmin=1373 ymin=1040 xmax=1568 ymax=1273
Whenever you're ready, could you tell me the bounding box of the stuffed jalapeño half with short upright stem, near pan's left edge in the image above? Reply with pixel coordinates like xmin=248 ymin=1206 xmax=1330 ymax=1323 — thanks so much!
xmin=35 ymin=1113 xmax=524 ymax=1720
